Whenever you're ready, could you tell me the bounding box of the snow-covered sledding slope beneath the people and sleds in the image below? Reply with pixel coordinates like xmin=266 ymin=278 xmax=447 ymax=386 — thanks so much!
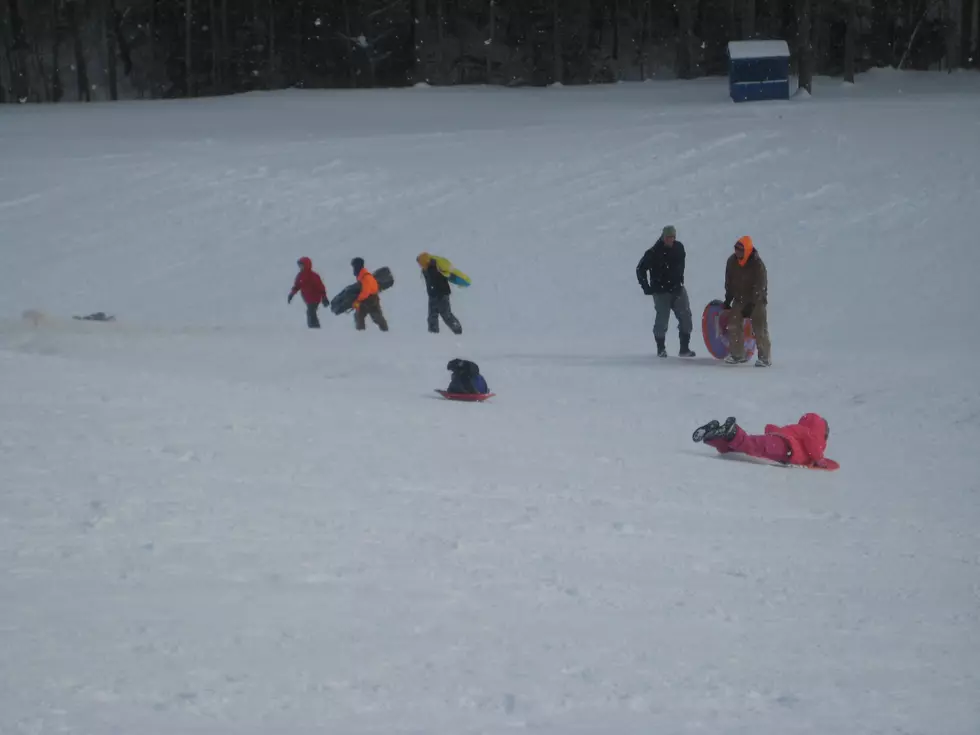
xmin=0 ymin=71 xmax=980 ymax=735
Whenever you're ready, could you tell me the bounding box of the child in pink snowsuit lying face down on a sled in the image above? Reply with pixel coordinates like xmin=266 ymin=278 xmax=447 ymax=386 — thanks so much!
xmin=693 ymin=413 xmax=830 ymax=467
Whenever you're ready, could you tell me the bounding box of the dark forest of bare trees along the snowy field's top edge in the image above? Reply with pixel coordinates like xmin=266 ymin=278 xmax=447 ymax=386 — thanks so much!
xmin=0 ymin=0 xmax=980 ymax=102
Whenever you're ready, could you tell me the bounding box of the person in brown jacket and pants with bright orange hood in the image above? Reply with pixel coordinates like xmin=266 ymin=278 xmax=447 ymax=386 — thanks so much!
xmin=725 ymin=235 xmax=772 ymax=367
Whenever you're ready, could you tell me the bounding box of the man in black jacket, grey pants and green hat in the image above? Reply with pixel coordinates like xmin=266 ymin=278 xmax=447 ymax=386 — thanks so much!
xmin=636 ymin=225 xmax=694 ymax=357
